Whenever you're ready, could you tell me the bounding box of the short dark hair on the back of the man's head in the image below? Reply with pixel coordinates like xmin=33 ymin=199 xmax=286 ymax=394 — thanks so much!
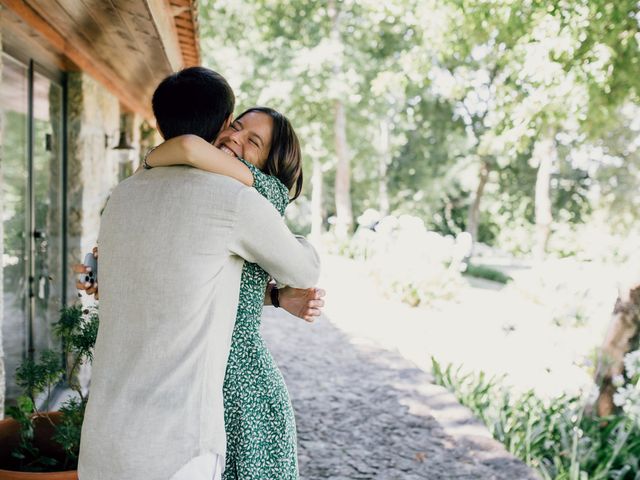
xmin=151 ymin=67 xmax=236 ymax=143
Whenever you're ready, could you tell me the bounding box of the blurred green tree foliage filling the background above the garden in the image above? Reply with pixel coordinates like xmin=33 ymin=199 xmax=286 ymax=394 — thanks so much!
xmin=200 ymin=0 xmax=640 ymax=254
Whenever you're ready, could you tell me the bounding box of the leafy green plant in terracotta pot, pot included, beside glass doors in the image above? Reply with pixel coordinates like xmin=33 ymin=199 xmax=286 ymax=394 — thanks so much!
xmin=0 ymin=305 xmax=98 ymax=480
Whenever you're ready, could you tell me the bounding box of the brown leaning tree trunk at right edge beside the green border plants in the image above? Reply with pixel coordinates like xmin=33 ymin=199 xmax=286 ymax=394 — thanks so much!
xmin=595 ymin=283 xmax=640 ymax=417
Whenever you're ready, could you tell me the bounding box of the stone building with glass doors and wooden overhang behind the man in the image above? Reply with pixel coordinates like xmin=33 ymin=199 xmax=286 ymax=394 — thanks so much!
xmin=0 ymin=0 xmax=199 ymax=418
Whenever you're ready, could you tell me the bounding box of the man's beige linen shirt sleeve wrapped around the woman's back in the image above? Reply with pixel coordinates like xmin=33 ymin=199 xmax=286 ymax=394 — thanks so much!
xmin=229 ymin=187 xmax=320 ymax=288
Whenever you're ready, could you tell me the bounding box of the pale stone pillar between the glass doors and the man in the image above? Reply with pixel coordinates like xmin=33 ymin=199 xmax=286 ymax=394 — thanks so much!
xmin=67 ymin=72 xmax=120 ymax=297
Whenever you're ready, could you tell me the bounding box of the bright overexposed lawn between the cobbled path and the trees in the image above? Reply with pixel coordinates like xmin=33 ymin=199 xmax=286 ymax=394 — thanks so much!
xmin=321 ymin=248 xmax=616 ymax=397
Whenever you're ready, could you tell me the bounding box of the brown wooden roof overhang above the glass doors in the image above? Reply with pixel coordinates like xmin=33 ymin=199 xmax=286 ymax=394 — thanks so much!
xmin=0 ymin=0 xmax=200 ymax=118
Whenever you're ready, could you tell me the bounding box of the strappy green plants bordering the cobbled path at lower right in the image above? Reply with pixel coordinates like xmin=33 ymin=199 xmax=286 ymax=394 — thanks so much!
xmin=431 ymin=357 xmax=640 ymax=480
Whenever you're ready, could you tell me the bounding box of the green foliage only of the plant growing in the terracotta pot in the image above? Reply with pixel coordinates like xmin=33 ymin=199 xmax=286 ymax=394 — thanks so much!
xmin=7 ymin=305 xmax=98 ymax=472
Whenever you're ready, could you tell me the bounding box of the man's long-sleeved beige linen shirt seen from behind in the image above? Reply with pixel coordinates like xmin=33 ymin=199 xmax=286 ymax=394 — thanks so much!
xmin=78 ymin=167 xmax=319 ymax=480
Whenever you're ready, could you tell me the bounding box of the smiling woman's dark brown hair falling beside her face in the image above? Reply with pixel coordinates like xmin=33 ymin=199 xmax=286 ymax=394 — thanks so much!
xmin=236 ymin=107 xmax=303 ymax=202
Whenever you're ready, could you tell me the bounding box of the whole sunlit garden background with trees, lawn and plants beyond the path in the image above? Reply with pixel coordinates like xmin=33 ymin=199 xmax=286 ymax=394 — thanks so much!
xmin=200 ymin=0 xmax=640 ymax=479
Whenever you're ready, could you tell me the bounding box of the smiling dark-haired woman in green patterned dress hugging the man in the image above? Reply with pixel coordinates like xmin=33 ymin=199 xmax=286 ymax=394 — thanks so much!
xmin=147 ymin=108 xmax=322 ymax=480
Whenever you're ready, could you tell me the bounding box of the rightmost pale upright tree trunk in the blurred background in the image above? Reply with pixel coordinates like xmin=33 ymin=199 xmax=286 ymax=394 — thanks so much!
xmin=533 ymin=135 xmax=557 ymax=260
